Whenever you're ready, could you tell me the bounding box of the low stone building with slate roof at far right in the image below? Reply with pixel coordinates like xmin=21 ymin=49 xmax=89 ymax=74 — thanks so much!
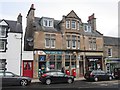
xmin=104 ymin=36 xmax=120 ymax=73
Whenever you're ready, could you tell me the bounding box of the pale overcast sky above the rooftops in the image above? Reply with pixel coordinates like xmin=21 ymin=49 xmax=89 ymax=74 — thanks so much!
xmin=0 ymin=0 xmax=119 ymax=37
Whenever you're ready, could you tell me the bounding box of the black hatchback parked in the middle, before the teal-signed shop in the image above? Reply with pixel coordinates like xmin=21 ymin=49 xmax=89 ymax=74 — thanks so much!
xmin=39 ymin=71 xmax=74 ymax=85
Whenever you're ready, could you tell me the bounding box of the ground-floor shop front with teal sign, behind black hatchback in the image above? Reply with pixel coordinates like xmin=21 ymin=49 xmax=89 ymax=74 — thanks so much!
xmin=36 ymin=50 xmax=83 ymax=77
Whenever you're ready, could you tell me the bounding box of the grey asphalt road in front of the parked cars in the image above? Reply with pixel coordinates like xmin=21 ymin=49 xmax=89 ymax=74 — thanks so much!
xmin=3 ymin=80 xmax=120 ymax=90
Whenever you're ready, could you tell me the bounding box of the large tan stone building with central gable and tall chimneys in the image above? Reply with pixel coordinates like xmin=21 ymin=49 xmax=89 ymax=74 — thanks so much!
xmin=24 ymin=4 xmax=103 ymax=78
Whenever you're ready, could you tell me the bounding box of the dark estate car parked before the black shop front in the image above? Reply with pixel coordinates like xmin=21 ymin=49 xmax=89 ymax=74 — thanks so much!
xmin=84 ymin=70 xmax=113 ymax=81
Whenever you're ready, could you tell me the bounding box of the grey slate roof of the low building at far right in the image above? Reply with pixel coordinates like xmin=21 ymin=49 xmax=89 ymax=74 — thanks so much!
xmin=103 ymin=36 xmax=120 ymax=45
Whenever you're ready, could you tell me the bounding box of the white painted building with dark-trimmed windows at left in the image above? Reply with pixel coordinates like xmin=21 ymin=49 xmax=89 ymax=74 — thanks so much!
xmin=0 ymin=14 xmax=23 ymax=75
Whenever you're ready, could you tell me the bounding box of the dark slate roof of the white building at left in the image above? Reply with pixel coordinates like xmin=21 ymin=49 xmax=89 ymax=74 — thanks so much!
xmin=0 ymin=19 xmax=23 ymax=33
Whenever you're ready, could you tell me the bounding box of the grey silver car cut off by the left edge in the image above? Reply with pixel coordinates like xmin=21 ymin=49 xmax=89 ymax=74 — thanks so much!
xmin=0 ymin=71 xmax=31 ymax=86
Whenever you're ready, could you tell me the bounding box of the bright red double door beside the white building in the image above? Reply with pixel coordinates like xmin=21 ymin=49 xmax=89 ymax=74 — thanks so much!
xmin=23 ymin=61 xmax=33 ymax=78
